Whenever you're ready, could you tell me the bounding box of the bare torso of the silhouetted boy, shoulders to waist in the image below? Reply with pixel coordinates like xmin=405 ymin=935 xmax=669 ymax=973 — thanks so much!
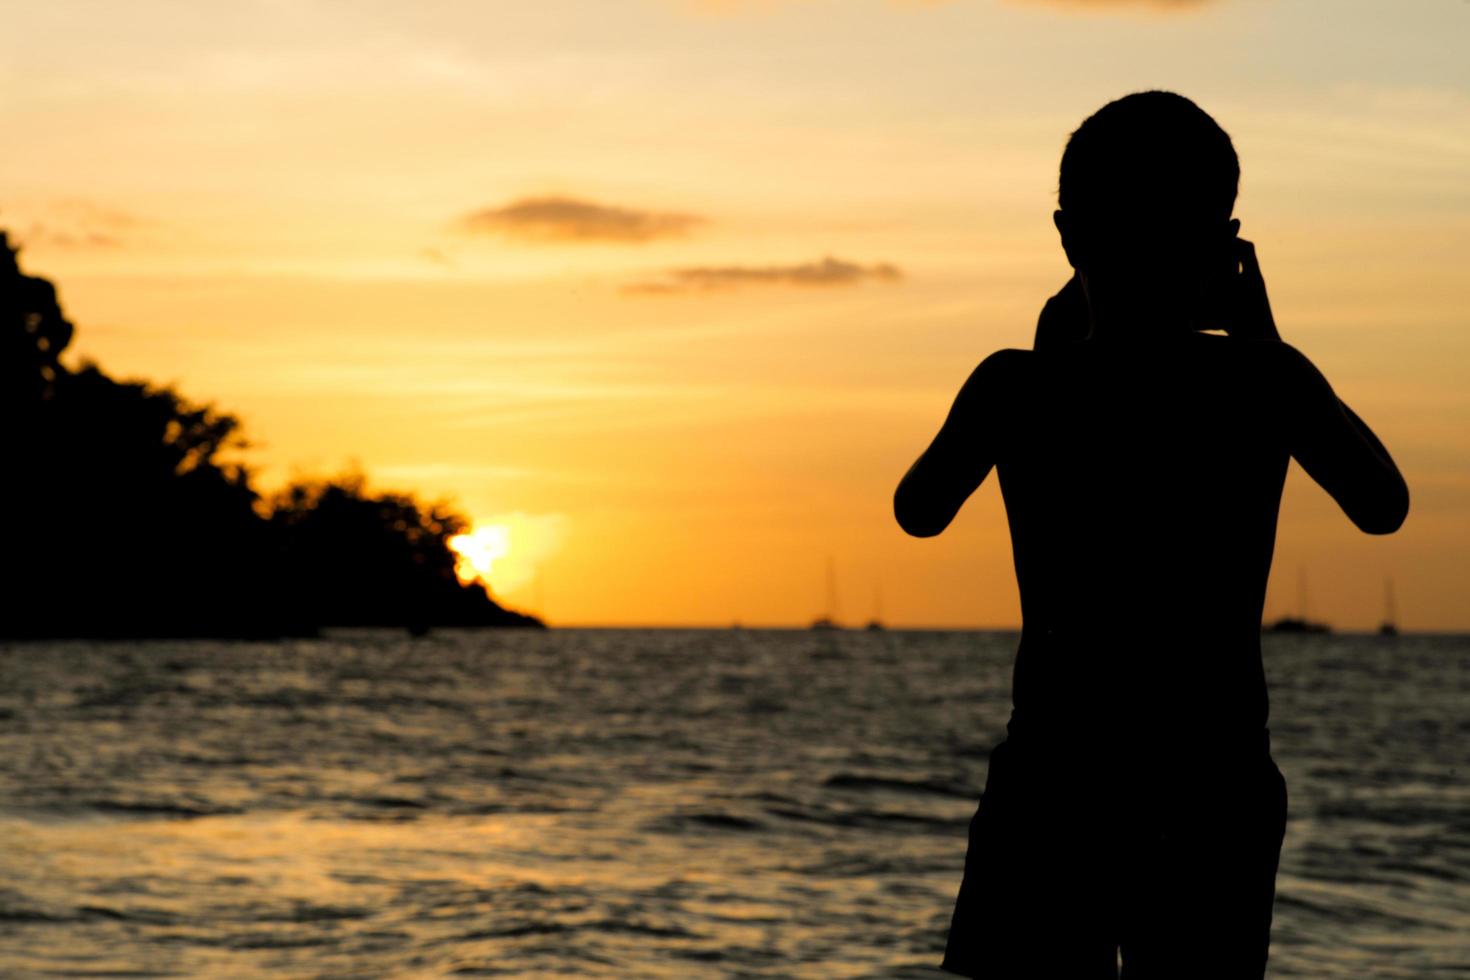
xmin=998 ymin=335 xmax=1288 ymax=743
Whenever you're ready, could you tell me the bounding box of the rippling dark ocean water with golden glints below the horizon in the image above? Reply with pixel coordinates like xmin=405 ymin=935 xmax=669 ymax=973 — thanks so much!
xmin=0 ymin=630 xmax=1470 ymax=980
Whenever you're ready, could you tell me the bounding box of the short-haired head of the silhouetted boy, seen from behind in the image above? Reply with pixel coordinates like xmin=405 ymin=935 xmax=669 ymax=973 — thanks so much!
xmin=1055 ymin=91 xmax=1241 ymax=293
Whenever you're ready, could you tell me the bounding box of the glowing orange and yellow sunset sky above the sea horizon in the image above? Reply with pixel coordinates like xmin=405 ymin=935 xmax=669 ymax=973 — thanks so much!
xmin=0 ymin=0 xmax=1470 ymax=629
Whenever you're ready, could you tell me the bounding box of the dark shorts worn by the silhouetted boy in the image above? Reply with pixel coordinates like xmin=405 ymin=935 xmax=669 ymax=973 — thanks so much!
xmin=942 ymin=732 xmax=1286 ymax=980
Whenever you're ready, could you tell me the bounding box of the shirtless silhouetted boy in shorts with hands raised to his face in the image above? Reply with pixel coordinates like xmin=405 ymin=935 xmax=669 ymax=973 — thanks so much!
xmin=894 ymin=93 xmax=1408 ymax=980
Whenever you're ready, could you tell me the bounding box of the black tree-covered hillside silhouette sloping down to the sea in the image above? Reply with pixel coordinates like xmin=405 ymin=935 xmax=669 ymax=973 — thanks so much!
xmin=0 ymin=232 xmax=541 ymax=638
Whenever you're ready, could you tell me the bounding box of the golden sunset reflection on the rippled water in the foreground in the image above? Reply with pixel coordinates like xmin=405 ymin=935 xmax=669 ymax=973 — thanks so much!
xmin=0 ymin=785 xmax=953 ymax=979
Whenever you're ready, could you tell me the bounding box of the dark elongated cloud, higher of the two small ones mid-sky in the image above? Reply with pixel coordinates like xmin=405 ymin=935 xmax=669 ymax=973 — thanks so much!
xmin=457 ymin=197 xmax=704 ymax=242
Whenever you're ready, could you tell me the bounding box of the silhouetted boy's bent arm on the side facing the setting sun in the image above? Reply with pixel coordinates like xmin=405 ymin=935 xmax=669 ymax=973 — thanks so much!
xmin=894 ymin=350 xmax=1028 ymax=538
